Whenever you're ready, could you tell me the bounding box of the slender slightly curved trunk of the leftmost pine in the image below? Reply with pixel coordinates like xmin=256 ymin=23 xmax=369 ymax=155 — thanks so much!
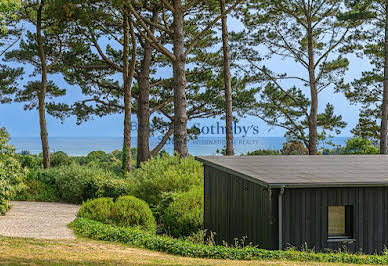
xmin=36 ymin=1 xmax=50 ymax=169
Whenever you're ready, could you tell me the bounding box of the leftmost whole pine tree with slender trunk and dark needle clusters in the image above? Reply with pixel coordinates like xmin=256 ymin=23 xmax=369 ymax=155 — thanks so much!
xmin=3 ymin=0 xmax=65 ymax=168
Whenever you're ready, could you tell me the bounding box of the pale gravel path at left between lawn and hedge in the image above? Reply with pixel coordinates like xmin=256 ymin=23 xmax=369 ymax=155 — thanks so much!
xmin=0 ymin=201 xmax=79 ymax=239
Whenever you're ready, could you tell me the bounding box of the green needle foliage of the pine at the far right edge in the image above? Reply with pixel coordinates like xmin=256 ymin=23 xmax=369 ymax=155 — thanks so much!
xmin=338 ymin=0 xmax=386 ymax=141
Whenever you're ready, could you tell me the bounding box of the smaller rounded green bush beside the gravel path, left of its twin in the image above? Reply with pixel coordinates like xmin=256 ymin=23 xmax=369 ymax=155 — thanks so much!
xmin=77 ymin=198 xmax=114 ymax=224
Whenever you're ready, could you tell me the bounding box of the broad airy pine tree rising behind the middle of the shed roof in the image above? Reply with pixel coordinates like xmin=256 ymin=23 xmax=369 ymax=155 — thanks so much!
xmin=237 ymin=0 xmax=359 ymax=155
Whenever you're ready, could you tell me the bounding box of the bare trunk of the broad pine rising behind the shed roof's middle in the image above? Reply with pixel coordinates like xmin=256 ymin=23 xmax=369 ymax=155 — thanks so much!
xmin=307 ymin=21 xmax=318 ymax=155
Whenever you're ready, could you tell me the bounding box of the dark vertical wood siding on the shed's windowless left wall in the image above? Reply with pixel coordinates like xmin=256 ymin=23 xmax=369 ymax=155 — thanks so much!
xmin=204 ymin=166 xmax=277 ymax=249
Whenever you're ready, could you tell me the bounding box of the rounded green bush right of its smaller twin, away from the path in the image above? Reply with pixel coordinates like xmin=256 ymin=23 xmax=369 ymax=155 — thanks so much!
xmin=112 ymin=196 xmax=156 ymax=232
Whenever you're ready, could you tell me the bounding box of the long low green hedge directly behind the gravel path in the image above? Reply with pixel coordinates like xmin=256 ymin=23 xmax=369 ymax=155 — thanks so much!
xmin=17 ymin=163 xmax=132 ymax=203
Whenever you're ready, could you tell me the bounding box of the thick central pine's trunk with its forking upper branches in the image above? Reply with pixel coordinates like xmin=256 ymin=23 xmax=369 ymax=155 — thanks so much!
xmin=128 ymin=0 xmax=241 ymax=157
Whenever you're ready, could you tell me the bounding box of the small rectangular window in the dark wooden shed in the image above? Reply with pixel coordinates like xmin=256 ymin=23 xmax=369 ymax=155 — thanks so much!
xmin=328 ymin=206 xmax=353 ymax=239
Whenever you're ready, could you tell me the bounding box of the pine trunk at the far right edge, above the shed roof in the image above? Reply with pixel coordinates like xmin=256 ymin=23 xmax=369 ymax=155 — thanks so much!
xmin=380 ymin=0 xmax=388 ymax=154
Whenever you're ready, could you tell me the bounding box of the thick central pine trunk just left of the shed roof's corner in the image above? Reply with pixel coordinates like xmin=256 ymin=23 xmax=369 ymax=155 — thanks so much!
xmin=173 ymin=0 xmax=188 ymax=157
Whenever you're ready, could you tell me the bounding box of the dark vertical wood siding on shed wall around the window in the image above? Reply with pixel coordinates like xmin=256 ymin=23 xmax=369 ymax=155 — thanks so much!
xmin=283 ymin=187 xmax=388 ymax=254
